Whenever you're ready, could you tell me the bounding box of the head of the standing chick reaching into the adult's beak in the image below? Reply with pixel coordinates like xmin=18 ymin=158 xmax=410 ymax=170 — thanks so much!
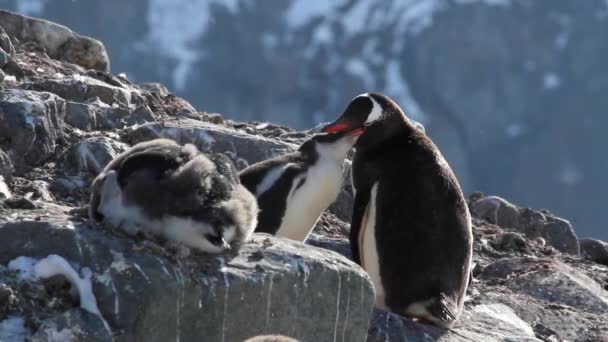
xmin=300 ymin=130 xmax=363 ymax=162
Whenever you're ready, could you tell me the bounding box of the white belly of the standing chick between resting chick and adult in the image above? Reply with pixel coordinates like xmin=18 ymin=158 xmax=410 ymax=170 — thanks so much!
xmin=275 ymin=159 xmax=342 ymax=242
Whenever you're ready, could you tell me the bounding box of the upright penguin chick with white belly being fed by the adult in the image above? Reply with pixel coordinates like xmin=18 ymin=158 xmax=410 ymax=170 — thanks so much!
xmin=239 ymin=132 xmax=359 ymax=242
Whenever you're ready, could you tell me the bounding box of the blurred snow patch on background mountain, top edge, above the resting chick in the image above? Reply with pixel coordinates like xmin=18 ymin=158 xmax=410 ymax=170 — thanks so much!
xmin=137 ymin=0 xmax=239 ymax=90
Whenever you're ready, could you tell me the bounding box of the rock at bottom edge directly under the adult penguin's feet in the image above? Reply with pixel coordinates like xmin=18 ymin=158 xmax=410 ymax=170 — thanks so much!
xmin=367 ymin=304 xmax=540 ymax=342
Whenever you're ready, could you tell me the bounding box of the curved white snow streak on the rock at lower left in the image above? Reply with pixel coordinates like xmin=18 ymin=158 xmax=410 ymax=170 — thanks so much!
xmin=8 ymin=254 xmax=109 ymax=330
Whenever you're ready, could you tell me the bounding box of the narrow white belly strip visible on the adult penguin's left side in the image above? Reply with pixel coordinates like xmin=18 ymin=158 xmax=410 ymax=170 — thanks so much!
xmin=359 ymin=183 xmax=386 ymax=309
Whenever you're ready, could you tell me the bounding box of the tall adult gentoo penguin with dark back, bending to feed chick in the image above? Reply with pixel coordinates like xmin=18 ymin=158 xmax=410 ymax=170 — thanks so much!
xmin=323 ymin=93 xmax=472 ymax=328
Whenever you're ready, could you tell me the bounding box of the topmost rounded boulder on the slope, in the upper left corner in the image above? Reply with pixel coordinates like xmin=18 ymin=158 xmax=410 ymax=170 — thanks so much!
xmin=0 ymin=10 xmax=110 ymax=71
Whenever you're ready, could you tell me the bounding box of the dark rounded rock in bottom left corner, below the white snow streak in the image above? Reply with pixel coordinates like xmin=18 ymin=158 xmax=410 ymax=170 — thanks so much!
xmin=31 ymin=308 xmax=114 ymax=342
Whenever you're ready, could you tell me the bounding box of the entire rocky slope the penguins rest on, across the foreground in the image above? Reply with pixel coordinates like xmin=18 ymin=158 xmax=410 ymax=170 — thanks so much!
xmin=0 ymin=11 xmax=608 ymax=341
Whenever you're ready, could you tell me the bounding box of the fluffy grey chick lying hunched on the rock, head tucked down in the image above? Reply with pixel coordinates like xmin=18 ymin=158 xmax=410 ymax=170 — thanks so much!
xmin=89 ymin=139 xmax=258 ymax=253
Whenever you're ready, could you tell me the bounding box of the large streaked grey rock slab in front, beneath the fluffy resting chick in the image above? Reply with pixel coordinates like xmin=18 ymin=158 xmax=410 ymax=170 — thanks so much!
xmin=0 ymin=204 xmax=374 ymax=341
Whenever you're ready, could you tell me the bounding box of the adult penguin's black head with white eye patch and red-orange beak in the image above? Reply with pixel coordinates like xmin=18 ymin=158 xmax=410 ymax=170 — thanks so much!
xmin=321 ymin=93 xmax=421 ymax=141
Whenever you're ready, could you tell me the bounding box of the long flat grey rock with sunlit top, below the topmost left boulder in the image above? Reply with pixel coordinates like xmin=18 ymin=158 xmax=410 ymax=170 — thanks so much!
xmin=22 ymin=75 xmax=131 ymax=107
